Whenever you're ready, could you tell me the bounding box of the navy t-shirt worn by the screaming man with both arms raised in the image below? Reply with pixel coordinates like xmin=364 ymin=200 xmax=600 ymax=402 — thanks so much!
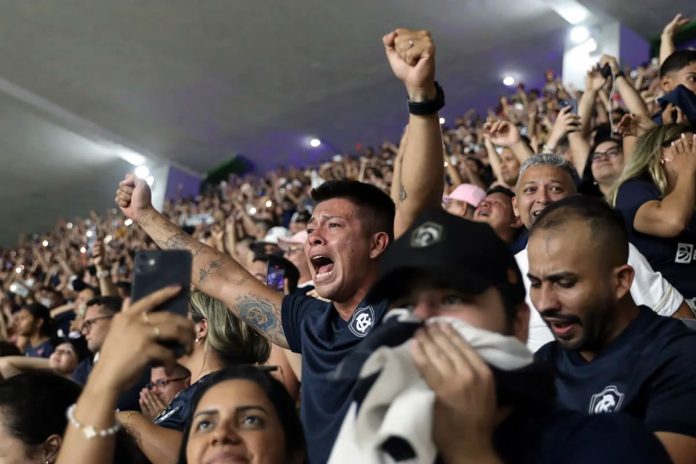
xmin=282 ymin=295 xmax=387 ymax=464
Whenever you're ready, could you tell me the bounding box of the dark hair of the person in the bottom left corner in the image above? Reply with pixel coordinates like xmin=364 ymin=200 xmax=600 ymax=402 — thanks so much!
xmin=0 ymin=372 xmax=82 ymax=447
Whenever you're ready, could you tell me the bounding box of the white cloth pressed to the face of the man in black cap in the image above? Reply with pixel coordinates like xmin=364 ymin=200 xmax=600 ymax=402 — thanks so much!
xmin=329 ymin=311 xmax=534 ymax=464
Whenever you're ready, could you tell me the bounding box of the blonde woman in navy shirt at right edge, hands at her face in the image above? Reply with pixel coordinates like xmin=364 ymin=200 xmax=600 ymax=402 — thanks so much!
xmin=611 ymin=124 xmax=696 ymax=300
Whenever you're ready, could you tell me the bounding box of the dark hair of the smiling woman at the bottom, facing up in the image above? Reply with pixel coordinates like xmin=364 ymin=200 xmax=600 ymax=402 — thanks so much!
xmin=179 ymin=366 xmax=305 ymax=464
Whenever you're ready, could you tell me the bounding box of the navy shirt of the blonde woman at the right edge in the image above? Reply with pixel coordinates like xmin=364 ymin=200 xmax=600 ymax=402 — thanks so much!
xmin=616 ymin=177 xmax=696 ymax=298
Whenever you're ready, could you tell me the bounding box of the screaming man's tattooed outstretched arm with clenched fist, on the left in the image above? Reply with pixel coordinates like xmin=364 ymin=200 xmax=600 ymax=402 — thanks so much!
xmin=116 ymin=174 xmax=288 ymax=347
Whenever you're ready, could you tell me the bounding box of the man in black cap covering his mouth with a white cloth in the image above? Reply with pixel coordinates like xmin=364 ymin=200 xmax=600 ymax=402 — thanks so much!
xmin=329 ymin=211 xmax=669 ymax=463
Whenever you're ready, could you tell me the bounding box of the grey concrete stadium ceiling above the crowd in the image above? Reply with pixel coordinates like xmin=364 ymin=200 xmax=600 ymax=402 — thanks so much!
xmin=0 ymin=0 xmax=693 ymax=244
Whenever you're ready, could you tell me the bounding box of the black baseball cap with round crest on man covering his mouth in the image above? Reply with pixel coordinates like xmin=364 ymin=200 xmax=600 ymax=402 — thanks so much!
xmin=367 ymin=210 xmax=525 ymax=304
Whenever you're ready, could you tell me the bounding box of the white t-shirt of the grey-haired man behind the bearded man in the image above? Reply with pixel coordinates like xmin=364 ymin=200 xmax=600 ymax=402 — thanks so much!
xmin=515 ymin=243 xmax=684 ymax=352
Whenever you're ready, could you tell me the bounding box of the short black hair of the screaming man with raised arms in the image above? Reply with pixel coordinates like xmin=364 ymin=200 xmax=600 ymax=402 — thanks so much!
xmin=312 ymin=180 xmax=396 ymax=242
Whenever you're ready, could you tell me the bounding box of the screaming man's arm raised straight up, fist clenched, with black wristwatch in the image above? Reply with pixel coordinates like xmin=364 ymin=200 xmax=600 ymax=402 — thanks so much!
xmin=382 ymin=29 xmax=445 ymax=237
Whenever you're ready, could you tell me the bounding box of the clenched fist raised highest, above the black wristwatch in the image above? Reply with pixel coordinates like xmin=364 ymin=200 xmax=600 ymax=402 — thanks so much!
xmin=382 ymin=29 xmax=435 ymax=101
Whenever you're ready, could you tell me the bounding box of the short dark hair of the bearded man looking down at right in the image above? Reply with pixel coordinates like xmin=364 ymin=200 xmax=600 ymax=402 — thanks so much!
xmin=529 ymin=195 xmax=628 ymax=264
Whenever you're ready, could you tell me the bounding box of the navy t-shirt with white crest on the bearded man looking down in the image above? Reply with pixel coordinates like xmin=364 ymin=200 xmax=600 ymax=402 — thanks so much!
xmin=535 ymin=306 xmax=696 ymax=437
